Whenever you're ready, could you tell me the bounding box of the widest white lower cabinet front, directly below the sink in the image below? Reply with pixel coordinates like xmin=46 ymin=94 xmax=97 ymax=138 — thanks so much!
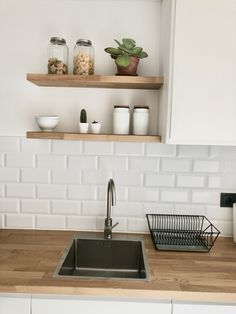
xmin=32 ymin=296 xmax=171 ymax=314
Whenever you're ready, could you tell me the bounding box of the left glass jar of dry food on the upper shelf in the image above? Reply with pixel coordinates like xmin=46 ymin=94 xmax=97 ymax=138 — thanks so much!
xmin=48 ymin=37 xmax=69 ymax=74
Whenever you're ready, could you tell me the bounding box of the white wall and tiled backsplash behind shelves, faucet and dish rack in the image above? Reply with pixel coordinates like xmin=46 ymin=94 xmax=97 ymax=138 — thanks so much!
xmin=0 ymin=0 xmax=236 ymax=235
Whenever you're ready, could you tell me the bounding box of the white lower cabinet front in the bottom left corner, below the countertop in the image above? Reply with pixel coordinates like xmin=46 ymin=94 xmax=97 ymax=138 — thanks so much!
xmin=0 ymin=294 xmax=30 ymax=314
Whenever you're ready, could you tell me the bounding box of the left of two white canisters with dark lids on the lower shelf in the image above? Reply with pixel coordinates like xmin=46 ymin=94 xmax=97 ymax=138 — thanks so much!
xmin=113 ymin=106 xmax=130 ymax=134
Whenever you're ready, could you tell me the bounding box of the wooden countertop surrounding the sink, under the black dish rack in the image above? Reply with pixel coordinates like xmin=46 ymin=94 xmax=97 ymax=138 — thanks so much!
xmin=0 ymin=229 xmax=236 ymax=302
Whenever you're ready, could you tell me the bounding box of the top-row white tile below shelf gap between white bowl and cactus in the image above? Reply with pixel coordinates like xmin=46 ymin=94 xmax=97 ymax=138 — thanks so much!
xmin=52 ymin=141 xmax=82 ymax=155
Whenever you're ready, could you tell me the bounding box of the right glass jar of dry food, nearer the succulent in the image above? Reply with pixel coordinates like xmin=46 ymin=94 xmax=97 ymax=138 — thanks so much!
xmin=73 ymin=39 xmax=94 ymax=75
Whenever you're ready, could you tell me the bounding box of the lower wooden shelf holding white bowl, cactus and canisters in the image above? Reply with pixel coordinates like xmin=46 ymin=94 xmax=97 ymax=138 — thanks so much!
xmin=26 ymin=131 xmax=161 ymax=143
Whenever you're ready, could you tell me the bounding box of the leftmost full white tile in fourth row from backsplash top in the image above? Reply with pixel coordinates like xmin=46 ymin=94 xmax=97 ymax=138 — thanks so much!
xmin=6 ymin=183 xmax=35 ymax=198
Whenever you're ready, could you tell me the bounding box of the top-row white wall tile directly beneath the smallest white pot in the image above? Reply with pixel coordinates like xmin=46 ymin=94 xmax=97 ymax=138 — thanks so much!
xmin=83 ymin=142 xmax=113 ymax=156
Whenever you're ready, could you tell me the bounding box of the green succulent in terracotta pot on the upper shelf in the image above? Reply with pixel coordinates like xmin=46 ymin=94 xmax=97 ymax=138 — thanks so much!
xmin=105 ymin=38 xmax=148 ymax=75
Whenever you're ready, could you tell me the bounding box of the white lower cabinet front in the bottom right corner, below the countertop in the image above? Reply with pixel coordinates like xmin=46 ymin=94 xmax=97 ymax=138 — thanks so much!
xmin=173 ymin=304 xmax=236 ymax=314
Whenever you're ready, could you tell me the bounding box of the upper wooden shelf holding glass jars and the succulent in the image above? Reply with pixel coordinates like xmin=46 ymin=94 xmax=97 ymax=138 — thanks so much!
xmin=27 ymin=73 xmax=164 ymax=89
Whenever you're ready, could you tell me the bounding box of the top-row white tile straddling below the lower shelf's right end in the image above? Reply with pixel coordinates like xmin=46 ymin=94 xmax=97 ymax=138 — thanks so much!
xmin=145 ymin=143 xmax=176 ymax=157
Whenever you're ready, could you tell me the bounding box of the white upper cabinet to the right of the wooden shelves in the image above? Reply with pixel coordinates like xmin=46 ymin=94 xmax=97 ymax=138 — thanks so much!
xmin=158 ymin=0 xmax=236 ymax=145
